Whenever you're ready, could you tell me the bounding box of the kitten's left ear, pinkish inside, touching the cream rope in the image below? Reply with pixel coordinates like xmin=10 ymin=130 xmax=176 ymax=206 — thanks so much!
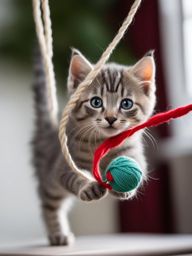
xmin=68 ymin=49 xmax=92 ymax=93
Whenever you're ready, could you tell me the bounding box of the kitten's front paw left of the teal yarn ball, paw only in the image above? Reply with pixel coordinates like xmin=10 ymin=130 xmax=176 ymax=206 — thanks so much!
xmin=79 ymin=181 xmax=107 ymax=201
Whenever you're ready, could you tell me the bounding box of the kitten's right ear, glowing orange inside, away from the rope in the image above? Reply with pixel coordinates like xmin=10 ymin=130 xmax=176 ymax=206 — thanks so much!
xmin=132 ymin=51 xmax=155 ymax=94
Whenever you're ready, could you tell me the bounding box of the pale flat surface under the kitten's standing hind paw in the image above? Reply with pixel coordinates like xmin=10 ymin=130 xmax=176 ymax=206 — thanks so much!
xmin=0 ymin=235 xmax=192 ymax=256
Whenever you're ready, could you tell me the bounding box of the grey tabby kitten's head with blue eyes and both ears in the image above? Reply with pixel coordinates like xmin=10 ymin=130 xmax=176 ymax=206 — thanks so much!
xmin=68 ymin=49 xmax=155 ymax=137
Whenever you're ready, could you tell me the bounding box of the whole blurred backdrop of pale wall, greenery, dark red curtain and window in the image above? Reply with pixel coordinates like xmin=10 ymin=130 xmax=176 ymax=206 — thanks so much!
xmin=0 ymin=0 xmax=192 ymax=245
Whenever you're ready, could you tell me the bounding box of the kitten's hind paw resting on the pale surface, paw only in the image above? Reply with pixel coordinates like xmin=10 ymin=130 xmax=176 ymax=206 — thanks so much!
xmin=49 ymin=233 xmax=75 ymax=246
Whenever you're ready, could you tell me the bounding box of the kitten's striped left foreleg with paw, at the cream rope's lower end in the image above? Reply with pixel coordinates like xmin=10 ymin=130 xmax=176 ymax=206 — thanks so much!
xmin=61 ymin=171 xmax=106 ymax=201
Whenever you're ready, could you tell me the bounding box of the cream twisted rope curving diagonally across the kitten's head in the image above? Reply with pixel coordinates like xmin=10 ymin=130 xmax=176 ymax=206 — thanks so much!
xmin=59 ymin=0 xmax=142 ymax=179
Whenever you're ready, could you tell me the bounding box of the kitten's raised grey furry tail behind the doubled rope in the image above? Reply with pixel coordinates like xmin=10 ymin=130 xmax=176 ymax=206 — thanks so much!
xmin=33 ymin=49 xmax=58 ymax=132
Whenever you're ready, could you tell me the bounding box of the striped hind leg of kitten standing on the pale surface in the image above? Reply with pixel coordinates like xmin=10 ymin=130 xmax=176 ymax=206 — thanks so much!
xmin=40 ymin=188 xmax=74 ymax=245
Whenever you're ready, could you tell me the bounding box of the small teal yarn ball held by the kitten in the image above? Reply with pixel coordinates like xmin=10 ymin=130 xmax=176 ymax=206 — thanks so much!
xmin=104 ymin=156 xmax=142 ymax=192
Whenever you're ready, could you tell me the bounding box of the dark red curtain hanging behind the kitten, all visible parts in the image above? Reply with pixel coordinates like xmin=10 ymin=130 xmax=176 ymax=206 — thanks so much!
xmin=109 ymin=0 xmax=174 ymax=233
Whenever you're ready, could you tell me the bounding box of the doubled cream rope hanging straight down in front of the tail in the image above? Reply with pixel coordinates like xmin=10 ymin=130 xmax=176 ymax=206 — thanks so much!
xmin=33 ymin=0 xmax=58 ymax=125
